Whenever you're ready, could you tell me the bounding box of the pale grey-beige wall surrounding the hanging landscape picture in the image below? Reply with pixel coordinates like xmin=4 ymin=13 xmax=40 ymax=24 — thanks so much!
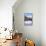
xmin=13 ymin=0 xmax=41 ymax=46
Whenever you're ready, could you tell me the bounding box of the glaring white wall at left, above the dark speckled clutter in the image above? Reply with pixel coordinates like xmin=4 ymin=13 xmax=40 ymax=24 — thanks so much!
xmin=0 ymin=0 xmax=16 ymax=29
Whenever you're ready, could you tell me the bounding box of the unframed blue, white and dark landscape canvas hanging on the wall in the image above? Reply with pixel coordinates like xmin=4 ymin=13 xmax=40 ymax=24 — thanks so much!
xmin=24 ymin=13 xmax=33 ymax=26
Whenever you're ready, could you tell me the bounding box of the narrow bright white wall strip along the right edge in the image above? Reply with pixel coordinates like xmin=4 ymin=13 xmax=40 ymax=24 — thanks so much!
xmin=40 ymin=0 xmax=46 ymax=46
